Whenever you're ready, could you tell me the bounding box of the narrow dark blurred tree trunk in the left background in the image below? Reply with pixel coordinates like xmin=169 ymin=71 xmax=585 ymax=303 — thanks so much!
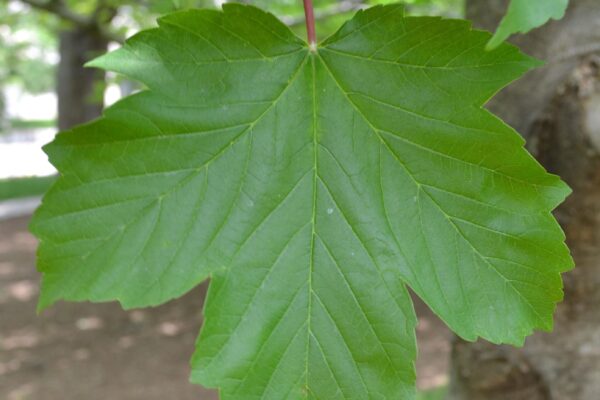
xmin=57 ymin=26 xmax=108 ymax=130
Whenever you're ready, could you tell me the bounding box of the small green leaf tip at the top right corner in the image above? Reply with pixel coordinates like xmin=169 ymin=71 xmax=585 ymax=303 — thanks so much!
xmin=487 ymin=0 xmax=569 ymax=49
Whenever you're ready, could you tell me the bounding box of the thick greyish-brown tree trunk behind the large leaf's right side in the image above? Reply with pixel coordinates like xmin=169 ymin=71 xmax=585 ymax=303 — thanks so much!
xmin=450 ymin=0 xmax=600 ymax=400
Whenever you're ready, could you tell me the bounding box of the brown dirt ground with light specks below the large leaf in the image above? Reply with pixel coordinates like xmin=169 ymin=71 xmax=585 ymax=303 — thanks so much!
xmin=0 ymin=218 xmax=450 ymax=400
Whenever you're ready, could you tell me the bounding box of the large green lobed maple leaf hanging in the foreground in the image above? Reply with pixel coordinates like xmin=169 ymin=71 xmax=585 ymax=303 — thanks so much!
xmin=32 ymin=4 xmax=572 ymax=399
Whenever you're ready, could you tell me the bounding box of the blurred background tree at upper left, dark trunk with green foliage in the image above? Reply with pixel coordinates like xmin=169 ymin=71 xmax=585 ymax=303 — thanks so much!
xmin=3 ymin=0 xmax=207 ymax=130
